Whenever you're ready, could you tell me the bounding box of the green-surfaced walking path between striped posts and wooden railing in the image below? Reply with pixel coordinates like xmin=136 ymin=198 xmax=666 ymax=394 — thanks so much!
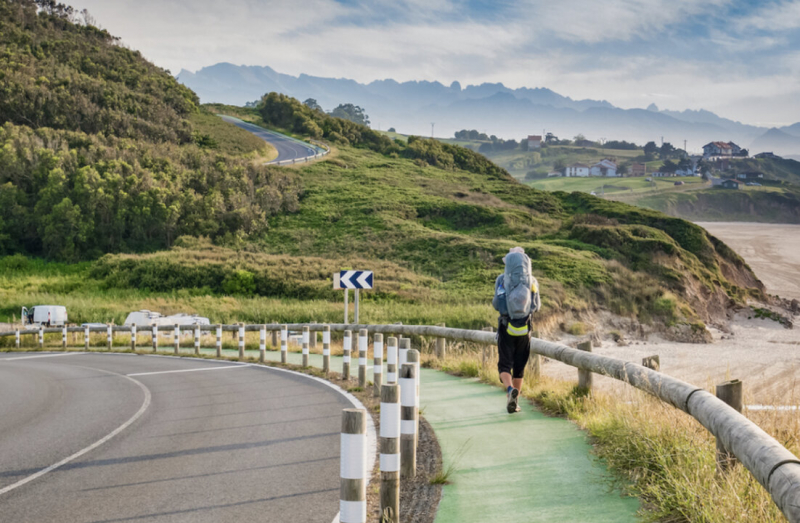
xmin=203 ymin=350 xmax=639 ymax=523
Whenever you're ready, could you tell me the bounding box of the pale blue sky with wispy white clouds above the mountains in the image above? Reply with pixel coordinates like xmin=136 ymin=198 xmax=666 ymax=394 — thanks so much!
xmin=71 ymin=0 xmax=800 ymax=125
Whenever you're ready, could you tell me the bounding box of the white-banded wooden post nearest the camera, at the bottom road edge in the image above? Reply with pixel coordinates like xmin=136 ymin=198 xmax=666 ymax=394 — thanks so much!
xmin=339 ymin=409 xmax=367 ymax=523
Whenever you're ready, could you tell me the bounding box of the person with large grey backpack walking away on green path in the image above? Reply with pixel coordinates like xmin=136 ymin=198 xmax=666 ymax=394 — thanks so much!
xmin=492 ymin=247 xmax=541 ymax=414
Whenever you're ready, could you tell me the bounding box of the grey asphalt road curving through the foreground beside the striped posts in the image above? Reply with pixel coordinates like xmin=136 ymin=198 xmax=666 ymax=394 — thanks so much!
xmin=0 ymin=353 xmax=351 ymax=523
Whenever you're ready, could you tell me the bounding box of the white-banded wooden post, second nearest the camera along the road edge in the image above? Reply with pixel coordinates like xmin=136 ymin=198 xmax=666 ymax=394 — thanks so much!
xmin=380 ymin=383 xmax=400 ymax=523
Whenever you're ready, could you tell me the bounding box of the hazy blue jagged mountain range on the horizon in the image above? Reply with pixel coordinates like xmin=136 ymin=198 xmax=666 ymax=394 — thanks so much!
xmin=178 ymin=63 xmax=800 ymax=155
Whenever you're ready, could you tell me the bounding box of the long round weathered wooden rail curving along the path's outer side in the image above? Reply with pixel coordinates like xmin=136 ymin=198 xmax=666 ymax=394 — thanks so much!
xmin=0 ymin=323 xmax=800 ymax=523
